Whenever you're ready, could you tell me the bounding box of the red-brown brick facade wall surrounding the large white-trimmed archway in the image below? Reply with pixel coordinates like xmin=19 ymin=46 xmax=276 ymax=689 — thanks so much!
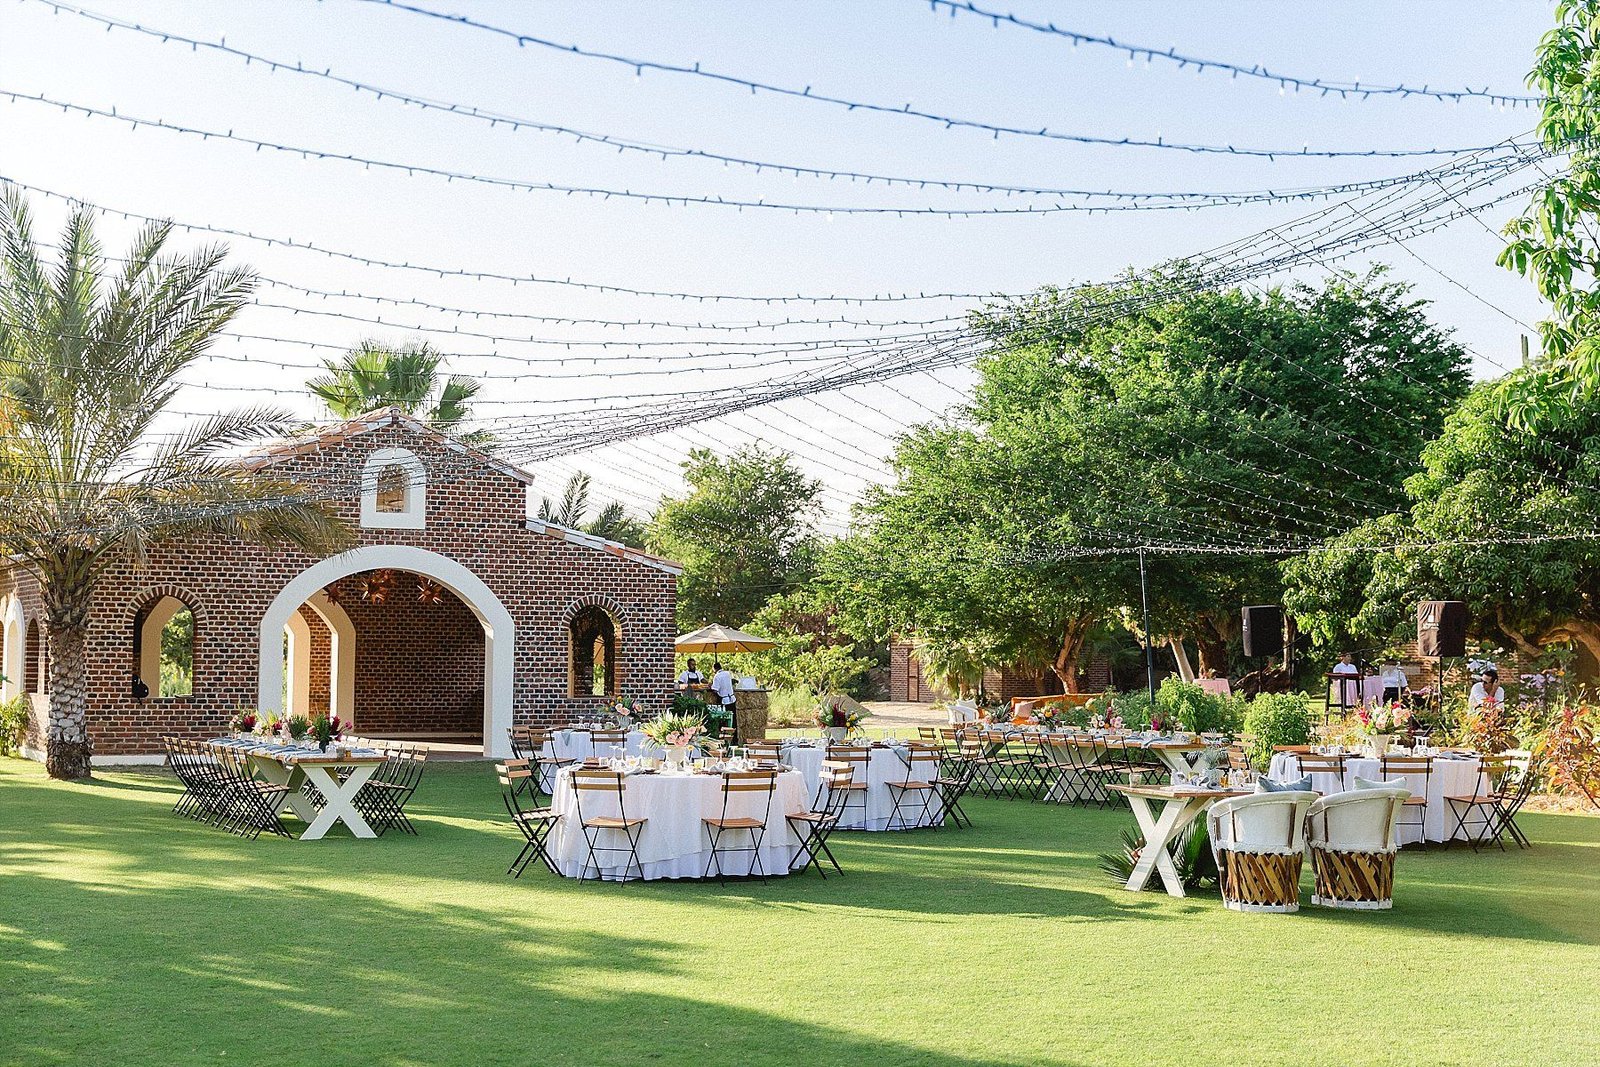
xmin=1 ymin=426 xmax=677 ymax=755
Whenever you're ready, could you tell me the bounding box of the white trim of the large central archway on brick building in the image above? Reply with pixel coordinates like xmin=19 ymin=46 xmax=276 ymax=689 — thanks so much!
xmin=256 ymin=544 xmax=517 ymax=757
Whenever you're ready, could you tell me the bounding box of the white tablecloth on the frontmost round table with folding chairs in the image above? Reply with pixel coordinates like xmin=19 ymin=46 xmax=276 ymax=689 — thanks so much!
xmin=549 ymin=771 xmax=810 ymax=880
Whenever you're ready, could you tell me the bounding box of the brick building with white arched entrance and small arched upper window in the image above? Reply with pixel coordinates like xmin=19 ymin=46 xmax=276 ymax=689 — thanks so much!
xmin=0 ymin=410 xmax=682 ymax=763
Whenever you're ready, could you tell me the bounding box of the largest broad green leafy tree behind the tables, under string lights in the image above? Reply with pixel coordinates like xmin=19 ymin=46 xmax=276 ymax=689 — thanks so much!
xmin=842 ymin=264 xmax=1466 ymax=689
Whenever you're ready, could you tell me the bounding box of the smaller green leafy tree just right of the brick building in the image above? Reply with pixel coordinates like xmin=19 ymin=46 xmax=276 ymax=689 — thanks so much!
xmin=648 ymin=446 xmax=822 ymax=629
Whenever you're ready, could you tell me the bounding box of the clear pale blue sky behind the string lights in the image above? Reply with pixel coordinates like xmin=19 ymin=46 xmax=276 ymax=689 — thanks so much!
xmin=0 ymin=0 xmax=1552 ymax=530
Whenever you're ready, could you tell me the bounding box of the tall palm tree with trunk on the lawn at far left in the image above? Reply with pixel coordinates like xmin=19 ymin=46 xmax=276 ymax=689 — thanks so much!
xmin=0 ymin=189 xmax=347 ymax=777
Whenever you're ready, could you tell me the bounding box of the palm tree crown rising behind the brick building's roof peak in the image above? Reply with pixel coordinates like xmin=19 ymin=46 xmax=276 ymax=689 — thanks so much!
xmin=306 ymin=341 xmax=491 ymax=443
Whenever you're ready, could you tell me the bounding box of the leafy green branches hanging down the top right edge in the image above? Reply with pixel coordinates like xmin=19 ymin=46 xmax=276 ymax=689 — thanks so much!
xmin=1499 ymin=0 xmax=1600 ymax=429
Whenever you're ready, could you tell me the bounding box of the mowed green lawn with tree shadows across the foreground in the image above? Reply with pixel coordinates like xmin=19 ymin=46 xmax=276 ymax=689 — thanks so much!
xmin=0 ymin=758 xmax=1600 ymax=1067
